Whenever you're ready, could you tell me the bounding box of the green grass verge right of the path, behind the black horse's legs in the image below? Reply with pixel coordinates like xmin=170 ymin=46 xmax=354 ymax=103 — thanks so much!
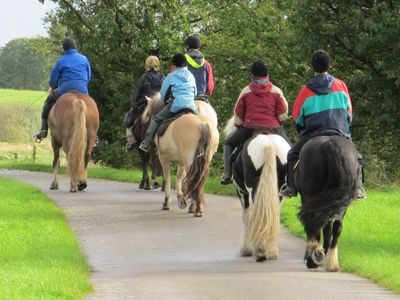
xmin=282 ymin=187 xmax=400 ymax=293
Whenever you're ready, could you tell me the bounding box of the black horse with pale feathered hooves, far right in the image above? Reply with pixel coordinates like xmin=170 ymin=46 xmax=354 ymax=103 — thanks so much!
xmin=295 ymin=136 xmax=360 ymax=272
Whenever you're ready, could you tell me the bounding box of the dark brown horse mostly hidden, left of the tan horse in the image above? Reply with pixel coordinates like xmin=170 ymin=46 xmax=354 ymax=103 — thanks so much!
xmin=132 ymin=93 xmax=164 ymax=190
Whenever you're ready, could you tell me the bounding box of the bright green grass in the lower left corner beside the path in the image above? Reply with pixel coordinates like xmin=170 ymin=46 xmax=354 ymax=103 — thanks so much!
xmin=0 ymin=177 xmax=92 ymax=299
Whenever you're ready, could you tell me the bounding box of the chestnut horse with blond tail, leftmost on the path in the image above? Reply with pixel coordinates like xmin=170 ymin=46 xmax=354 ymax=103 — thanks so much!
xmin=48 ymin=93 xmax=99 ymax=192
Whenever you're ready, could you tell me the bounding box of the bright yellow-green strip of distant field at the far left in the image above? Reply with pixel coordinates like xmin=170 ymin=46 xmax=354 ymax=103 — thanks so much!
xmin=0 ymin=89 xmax=47 ymax=107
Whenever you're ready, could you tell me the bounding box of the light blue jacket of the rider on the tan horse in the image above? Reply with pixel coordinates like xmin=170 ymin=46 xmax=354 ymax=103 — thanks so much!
xmin=160 ymin=67 xmax=197 ymax=113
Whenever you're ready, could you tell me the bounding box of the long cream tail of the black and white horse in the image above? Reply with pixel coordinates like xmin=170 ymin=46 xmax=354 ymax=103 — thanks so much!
xmin=248 ymin=144 xmax=280 ymax=257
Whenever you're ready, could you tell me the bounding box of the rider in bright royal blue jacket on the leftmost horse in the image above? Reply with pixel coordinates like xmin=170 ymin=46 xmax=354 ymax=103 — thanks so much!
xmin=36 ymin=37 xmax=92 ymax=141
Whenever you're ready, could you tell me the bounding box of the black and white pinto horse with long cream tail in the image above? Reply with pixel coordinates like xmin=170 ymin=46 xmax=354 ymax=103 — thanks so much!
xmin=225 ymin=122 xmax=290 ymax=261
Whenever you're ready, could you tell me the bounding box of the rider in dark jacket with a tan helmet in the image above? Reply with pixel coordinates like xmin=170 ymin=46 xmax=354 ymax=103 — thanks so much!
xmin=124 ymin=56 xmax=164 ymax=151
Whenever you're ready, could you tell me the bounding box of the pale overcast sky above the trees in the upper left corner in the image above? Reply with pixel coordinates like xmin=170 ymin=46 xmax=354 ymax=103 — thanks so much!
xmin=0 ymin=0 xmax=55 ymax=47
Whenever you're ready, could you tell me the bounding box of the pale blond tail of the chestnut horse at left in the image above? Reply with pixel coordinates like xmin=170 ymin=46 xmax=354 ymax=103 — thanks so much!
xmin=68 ymin=98 xmax=87 ymax=180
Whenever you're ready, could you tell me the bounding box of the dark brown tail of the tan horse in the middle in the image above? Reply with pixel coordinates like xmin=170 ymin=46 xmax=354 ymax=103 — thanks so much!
xmin=183 ymin=122 xmax=211 ymax=203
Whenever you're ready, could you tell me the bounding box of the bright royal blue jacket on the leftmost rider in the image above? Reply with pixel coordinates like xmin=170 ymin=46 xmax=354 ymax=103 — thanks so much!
xmin=49 ymin=49 xmax=92 ymax=96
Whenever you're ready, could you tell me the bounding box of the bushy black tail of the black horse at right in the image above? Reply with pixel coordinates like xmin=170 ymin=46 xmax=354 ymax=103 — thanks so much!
xmin=298 ymin=140 xmax=355 ymax=232
